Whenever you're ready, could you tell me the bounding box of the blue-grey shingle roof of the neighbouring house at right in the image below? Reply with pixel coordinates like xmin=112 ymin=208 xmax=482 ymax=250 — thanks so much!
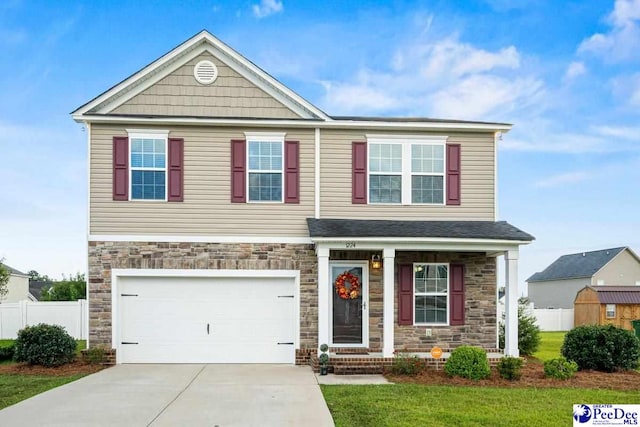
xmin=527 ymin=247 xmax=626 ymax=283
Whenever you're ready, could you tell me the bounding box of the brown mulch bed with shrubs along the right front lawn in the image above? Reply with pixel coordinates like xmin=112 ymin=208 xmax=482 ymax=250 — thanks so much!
xmin=385 ymin=359 xmax=640 ymax=390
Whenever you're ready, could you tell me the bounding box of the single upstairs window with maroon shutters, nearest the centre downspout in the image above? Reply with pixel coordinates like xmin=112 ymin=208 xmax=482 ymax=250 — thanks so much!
xmin=247 ymin=134 xmax=284 ymax=202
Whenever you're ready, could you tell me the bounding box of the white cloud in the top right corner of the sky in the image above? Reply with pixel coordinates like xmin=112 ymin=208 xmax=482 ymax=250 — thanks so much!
xmin=578 ymin=0 xmax=640 ymax=62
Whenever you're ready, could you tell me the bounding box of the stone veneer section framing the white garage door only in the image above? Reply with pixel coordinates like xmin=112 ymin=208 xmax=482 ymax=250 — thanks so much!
xmin=88 ymin=242 xmax=318 ymax=350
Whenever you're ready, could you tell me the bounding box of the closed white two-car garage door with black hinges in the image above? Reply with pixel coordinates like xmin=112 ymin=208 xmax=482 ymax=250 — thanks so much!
xmin=117 ymin=277 xmax=296 ymax=363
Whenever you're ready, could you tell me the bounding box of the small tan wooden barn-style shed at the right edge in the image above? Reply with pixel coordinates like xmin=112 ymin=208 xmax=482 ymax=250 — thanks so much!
xmin=573 ymin=286 xmax=640 ymax=330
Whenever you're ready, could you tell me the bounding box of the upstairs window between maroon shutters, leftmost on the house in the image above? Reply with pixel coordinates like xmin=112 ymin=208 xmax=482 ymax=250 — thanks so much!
xmin=129 ymin=132 xmax=168 ymax=200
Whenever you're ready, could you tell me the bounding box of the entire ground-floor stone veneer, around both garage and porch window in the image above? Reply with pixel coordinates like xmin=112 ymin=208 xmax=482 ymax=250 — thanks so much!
xmin=89 ymin=242 xmax=497 ymax=363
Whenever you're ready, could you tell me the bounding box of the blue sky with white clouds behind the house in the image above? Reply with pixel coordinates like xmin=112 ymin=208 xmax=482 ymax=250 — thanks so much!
xmin=0 ymin=0 xmax=640 ymax=290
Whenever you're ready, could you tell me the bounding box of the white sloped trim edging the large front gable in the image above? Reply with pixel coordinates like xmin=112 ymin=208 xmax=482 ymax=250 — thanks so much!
xmin=72 ymin=31 xmax=331 ymax=121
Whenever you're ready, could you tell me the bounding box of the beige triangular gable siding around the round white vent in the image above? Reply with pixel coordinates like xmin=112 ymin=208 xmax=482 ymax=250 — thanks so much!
xmin=111 ymin=53 xmax=299 ymax=119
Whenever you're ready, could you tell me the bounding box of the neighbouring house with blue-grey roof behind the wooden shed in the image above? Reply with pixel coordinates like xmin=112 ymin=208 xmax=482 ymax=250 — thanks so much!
xmin=527 ymin=247 xmax=640 ymax=308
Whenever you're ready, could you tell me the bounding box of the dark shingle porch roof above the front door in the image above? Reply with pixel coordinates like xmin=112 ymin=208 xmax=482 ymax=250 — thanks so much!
xmin=307 ymin=218 xmax=535 ymax=241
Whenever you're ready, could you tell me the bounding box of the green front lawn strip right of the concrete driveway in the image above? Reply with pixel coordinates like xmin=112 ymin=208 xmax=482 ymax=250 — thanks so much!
xmin=321 ymin=384 xmax=638 ymax=427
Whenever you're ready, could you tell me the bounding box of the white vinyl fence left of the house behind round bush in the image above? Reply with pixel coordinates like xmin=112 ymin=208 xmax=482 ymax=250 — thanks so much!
xmin=0 ymin=300 xmax=88 ymax=340
